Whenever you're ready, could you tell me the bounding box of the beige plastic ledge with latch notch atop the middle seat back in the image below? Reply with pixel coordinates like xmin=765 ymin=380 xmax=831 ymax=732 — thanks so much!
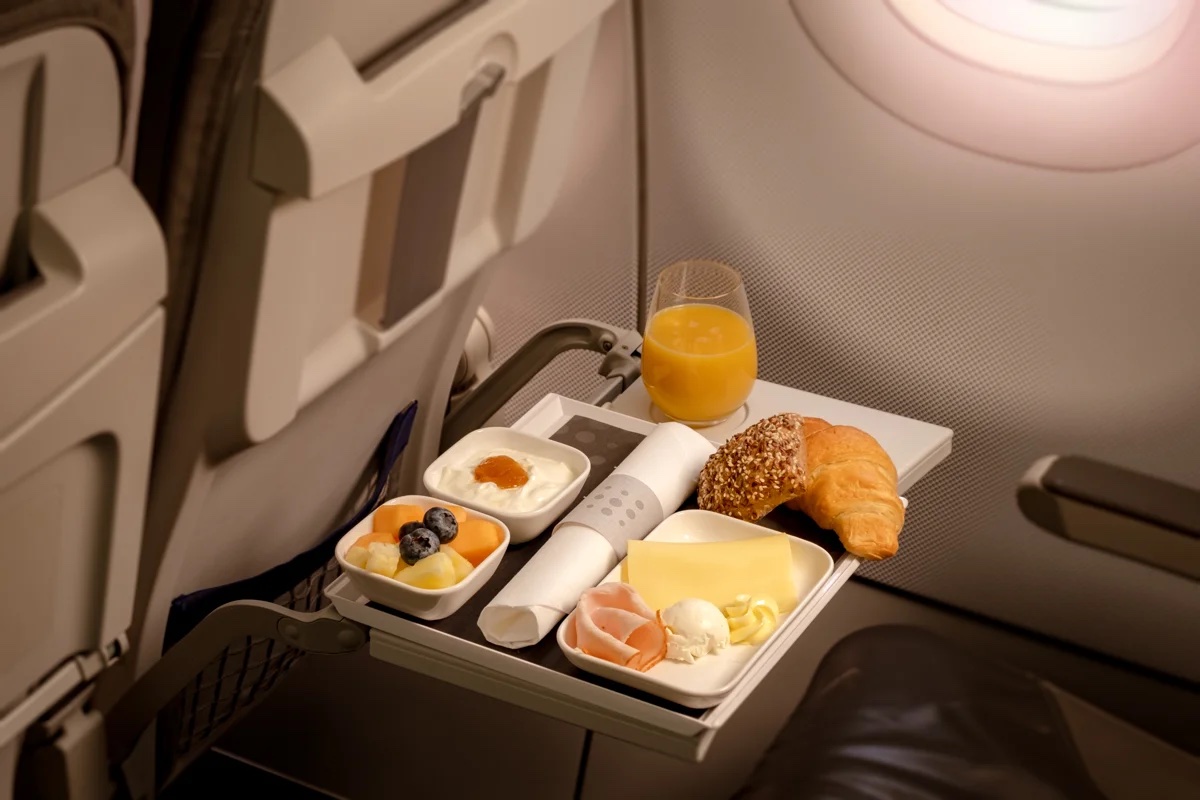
xmin=254 ymin=0 xmax=613 ymax=197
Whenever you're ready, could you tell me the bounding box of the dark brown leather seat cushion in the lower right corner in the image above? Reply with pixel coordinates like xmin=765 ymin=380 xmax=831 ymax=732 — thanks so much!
xmin=737 ymin=625 xmax=1200 ymax=800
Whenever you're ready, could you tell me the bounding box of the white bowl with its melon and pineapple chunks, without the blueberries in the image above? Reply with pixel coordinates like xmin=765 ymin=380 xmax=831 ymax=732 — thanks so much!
xmin=334 ymin=494 xmax=511 ymax=620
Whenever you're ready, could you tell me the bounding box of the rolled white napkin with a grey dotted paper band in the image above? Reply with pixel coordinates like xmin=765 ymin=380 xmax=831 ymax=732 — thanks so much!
xmin=479 ymin=422 xmax=716 ymax=649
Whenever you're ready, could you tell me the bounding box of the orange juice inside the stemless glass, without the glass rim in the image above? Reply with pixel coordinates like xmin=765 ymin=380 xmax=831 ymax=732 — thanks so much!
xmin=642 ymin=303 xmax=758 ymax=422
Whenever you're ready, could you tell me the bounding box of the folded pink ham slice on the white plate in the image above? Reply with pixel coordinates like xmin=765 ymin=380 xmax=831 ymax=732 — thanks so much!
xmin=575 ymin=583 xmax=667 ymax=672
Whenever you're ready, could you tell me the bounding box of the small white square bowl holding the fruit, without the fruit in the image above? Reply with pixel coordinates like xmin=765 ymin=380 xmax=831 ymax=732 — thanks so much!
xmin=334 ymin=494 xmax=511 ymax=620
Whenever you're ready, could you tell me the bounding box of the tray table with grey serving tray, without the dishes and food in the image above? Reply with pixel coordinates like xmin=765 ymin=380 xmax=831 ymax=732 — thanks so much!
xmin=326 ymin=384 xmax=950 ymax=762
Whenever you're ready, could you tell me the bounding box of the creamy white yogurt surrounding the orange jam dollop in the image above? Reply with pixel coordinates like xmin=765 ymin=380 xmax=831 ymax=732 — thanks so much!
xmin=437 ymin=447 xmax=577 ymax=513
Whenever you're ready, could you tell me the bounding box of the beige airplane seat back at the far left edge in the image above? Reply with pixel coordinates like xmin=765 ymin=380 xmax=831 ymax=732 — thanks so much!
xmin=0 ymin=0 xmax=166 ymax=798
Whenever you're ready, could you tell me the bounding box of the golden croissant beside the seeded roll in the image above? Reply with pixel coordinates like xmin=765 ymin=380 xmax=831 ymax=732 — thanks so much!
xmin=787 ymin=417 xmax=904 ymax=559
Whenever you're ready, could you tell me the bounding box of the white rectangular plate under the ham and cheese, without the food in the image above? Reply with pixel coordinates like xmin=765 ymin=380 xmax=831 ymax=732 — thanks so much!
xmin=558 ymin=511 xmax=833 ymax=709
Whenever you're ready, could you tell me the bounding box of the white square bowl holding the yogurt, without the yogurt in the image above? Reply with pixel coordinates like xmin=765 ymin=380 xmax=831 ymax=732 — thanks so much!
xmin=425 ymin=428 xmax=592 ymax=543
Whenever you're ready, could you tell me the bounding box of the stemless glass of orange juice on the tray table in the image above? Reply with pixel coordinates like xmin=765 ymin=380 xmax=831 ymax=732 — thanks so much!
xmin=642 ymin=261 xmax=758 ymax=427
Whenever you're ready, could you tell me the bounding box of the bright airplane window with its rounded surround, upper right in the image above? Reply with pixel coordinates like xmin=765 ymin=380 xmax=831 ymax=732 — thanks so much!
xmin=791 ymin=0 xmax=1200 ymax=170
